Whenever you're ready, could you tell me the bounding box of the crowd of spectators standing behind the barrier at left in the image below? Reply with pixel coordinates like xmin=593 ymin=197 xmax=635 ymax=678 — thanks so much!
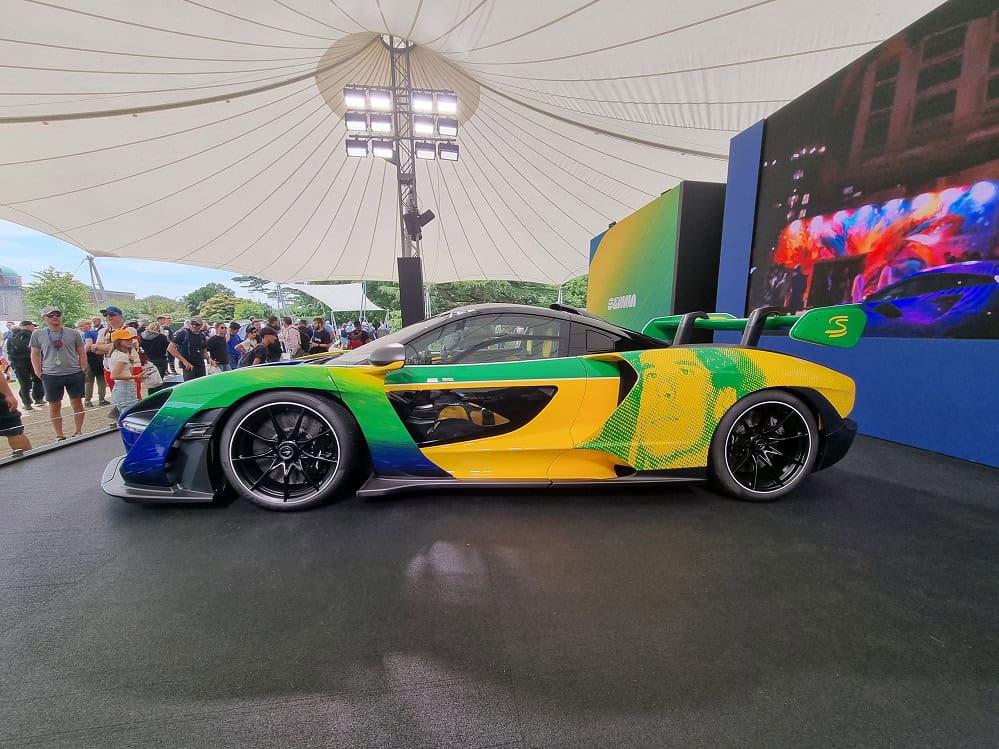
xmin=0 ymin=305 xmax=389 ymax=455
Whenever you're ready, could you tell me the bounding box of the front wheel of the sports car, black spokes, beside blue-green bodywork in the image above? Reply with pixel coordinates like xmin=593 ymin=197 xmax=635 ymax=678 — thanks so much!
xmin=218 ymin=390 xmax=364 ymax=511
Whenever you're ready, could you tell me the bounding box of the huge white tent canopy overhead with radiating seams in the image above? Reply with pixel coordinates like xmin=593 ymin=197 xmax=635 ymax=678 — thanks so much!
xmin=0 ymin=0 xmax=937 ymax=283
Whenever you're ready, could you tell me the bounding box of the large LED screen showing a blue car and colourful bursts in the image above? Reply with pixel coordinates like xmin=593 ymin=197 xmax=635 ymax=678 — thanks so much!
xmin=747 ymin=0 xmax=999 ymax=338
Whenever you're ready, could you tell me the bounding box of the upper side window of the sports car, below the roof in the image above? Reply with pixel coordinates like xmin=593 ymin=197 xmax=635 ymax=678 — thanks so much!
xmin=406 ymin=314 xmax=566 ymax=364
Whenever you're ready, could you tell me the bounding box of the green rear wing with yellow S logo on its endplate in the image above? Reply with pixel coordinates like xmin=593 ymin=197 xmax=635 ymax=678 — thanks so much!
xmin=642 ymin=304 xmax=867 ymax=348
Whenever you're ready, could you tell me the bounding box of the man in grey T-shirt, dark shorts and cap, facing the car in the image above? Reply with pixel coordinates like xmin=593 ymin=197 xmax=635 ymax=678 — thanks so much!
xmin=31 ymin=307 xmax=87 ymax=441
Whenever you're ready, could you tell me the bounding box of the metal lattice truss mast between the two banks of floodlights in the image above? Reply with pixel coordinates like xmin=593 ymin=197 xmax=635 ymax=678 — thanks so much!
xmin=388 ymin=35 xmax=420 ymax=257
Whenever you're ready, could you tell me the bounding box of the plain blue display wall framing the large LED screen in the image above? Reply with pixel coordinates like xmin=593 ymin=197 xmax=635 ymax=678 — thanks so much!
xmin=716 ymin=122 xmax=999 ymax=467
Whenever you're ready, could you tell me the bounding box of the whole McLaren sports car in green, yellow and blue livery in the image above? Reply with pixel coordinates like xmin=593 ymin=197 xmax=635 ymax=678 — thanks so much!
xmin=102 ymin=305 xmax=865 ymax=510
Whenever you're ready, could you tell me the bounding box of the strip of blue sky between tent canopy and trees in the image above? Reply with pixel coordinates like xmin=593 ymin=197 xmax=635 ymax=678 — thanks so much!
xmin=0 ymin=220 xmax=266 ymax=301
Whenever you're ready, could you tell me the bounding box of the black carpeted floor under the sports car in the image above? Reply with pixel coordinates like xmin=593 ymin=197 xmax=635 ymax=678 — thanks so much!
xmin=0 ymin=436 xmax=999 ymax=749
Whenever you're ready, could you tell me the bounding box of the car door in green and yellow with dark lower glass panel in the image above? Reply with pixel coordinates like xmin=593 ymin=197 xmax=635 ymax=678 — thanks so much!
xmin=385 ymin=312 xmax=587 ymax=480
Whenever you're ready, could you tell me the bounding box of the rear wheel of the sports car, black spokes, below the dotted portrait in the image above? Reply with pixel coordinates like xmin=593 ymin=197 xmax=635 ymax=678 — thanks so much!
xmin=708 ymin=390 xmax=819 ymax=502
